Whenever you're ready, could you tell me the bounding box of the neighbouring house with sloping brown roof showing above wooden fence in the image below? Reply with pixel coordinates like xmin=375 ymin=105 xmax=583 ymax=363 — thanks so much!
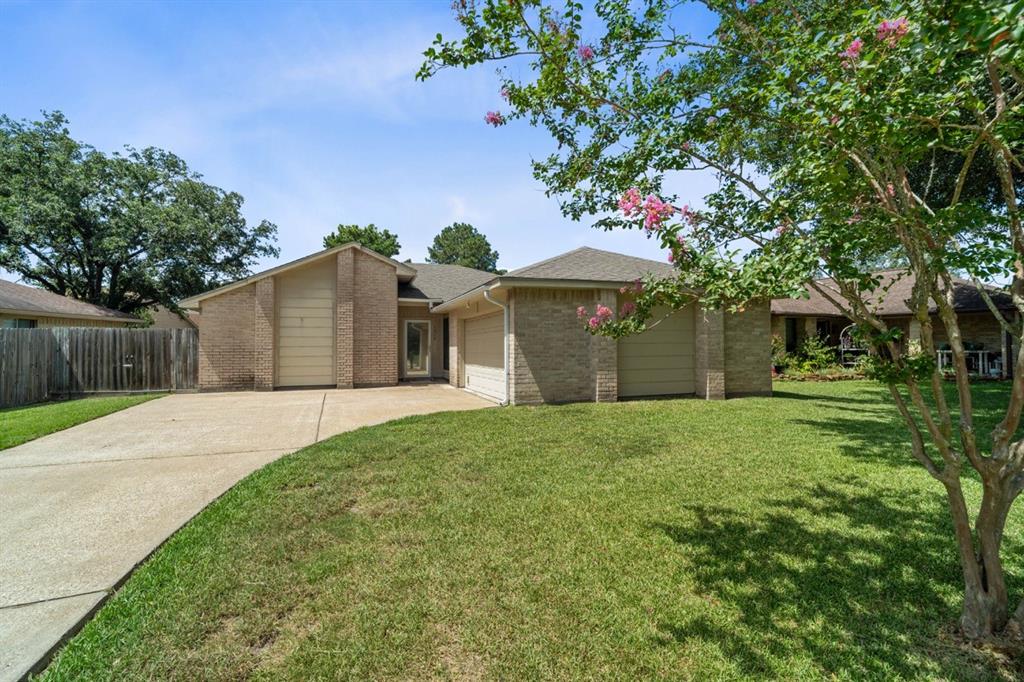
xmin=0 ymin=280 xmax=141 ymax=329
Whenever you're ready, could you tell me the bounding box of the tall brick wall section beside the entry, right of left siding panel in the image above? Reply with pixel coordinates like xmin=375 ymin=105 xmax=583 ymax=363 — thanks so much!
xmin=354 ymin=249 xmax=398 ymax=386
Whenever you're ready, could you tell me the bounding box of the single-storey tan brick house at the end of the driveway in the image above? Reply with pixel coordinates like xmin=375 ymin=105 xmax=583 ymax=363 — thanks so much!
xmin=181 ymin=244 xmax=771 ymax=404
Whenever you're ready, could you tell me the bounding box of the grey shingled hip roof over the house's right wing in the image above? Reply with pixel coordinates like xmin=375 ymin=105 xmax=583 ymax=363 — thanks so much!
xmin=503 ymin=247 xmax=676 ymax=283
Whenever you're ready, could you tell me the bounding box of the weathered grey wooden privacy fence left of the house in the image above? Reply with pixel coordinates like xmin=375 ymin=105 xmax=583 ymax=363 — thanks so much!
xmin=0 ymin=327 xmax=199 ymax=408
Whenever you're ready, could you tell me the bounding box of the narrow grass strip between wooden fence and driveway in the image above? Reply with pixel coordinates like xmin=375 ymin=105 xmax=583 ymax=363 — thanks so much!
xmin=0 ymin=393 xmax=163 ymax=450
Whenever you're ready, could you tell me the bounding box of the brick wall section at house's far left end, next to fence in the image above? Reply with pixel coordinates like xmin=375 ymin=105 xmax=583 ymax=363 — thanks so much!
xmin=197 ymin=285 xmax=256 ymax=390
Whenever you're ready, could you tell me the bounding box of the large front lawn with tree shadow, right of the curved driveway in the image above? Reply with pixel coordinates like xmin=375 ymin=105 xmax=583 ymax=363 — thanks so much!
xmin=39 ymin=382 xmax=1024 ymax=680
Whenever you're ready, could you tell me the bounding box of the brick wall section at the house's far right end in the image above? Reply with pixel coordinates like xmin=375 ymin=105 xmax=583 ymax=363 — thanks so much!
xmin=724 ymin=302 xmax=771 ymax=396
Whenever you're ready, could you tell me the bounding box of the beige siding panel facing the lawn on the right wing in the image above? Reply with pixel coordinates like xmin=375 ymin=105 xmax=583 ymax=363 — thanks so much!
xmin=618 ymin=306 xmax=695 ymax=397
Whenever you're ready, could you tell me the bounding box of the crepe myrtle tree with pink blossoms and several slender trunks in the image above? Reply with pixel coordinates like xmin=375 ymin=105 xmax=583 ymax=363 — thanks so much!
xmin=420 ymin=0 xmax=1024 ymax=641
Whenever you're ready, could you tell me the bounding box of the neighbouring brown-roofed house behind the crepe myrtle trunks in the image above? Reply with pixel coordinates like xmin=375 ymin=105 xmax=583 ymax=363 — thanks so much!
xmin=771 ymin=268 xmax=1017 ymax=377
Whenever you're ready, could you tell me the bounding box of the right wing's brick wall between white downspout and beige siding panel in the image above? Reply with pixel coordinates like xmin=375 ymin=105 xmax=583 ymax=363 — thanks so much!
xmin=510 ymin=289 xmax=617 ymax=404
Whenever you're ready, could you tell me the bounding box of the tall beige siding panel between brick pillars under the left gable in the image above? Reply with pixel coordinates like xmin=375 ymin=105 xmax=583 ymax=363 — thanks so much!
xmin=274 ymin=258 xmax=337 ymax=386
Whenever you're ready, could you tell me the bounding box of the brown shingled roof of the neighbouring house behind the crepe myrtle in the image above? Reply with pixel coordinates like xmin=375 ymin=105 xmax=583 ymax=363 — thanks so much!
xmin=771 ymin=268 xmax=1014 ymax=315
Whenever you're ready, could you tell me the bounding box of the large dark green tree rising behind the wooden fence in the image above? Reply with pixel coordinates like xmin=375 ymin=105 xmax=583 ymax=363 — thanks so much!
xmin=0 ymin=113 xmax=278 ymax=313
